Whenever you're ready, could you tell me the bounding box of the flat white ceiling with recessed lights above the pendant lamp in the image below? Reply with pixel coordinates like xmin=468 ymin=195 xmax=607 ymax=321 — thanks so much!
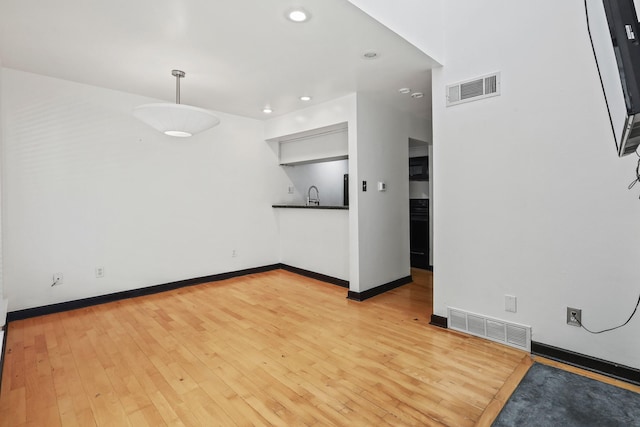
xmin=0 ymin=0 xmax=435 ymax=119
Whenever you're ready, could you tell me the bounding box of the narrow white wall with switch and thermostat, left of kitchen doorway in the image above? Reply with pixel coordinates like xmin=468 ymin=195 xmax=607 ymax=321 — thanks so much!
xmin=350 ymin=93 xmax=420 ymax=292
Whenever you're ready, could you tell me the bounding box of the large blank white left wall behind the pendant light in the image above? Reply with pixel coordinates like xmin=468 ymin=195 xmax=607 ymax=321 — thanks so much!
xmin=1 ymin=69 xmax=287 ymax=311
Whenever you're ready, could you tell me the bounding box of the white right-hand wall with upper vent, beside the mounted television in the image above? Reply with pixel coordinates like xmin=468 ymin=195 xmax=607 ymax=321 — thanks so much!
xmin=432 ymin=0 xmax=640 ymax=368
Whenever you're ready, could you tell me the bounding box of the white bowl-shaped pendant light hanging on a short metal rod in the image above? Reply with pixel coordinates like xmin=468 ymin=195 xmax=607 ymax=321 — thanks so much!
xmin=133 ymin=70 xmax=220 ymax=137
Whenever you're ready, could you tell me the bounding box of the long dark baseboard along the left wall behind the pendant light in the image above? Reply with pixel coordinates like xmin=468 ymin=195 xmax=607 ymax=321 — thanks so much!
xmin=5 ymin=264 xmax=281 ymax=320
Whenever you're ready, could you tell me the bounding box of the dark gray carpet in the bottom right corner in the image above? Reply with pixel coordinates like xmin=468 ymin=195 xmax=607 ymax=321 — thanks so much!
xmin=493 ymin=363 xmax=640 ymax=427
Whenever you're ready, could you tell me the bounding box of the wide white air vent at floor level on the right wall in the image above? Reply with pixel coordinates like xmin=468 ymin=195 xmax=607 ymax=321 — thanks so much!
xmin=447 ymin=307 xmax=531 ymax=351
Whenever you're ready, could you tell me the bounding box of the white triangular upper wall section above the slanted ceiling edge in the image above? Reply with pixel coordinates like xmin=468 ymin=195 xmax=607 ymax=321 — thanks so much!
xmin=349 ymin=0 xmax=444 ymax=64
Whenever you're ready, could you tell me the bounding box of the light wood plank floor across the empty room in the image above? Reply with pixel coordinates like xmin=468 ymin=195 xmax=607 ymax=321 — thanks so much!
xmin=0 ymin=270 xmax=531 ymax=427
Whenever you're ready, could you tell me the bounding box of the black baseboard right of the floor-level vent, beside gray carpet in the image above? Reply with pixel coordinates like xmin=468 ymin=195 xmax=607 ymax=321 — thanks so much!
xmin=531 ymin=341 xmax=640 ymax=385
